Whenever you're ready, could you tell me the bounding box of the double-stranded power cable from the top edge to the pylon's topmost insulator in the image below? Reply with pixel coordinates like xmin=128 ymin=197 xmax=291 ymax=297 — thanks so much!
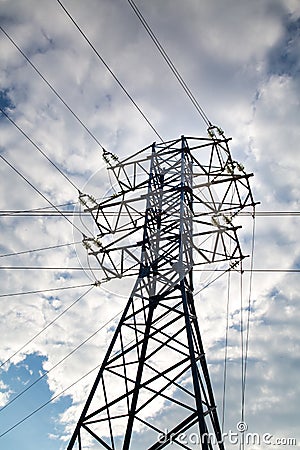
xmin=127 ymin=0 xmax=212 ymax=126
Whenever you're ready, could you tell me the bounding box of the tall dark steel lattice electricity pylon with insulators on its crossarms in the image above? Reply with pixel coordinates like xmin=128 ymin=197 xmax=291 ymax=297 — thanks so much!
xmin=68 ymin=131 xmax=254 ymax=450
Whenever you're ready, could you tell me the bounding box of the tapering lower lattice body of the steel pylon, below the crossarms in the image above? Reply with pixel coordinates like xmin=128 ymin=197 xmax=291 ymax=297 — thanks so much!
xmin=68 ymin=277 xmax=223 ymax=450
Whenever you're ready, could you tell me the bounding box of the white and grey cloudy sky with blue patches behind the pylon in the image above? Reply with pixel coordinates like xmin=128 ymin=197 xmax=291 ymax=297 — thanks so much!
xmin=0 ymin=0 xmax=300 ymax=450
